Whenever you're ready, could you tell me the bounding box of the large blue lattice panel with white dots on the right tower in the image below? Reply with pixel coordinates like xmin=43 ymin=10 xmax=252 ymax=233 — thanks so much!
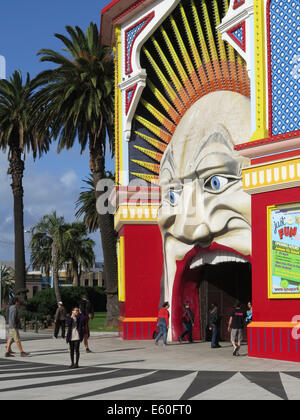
xmin=269 ymin=0 xmax=300 ymax=136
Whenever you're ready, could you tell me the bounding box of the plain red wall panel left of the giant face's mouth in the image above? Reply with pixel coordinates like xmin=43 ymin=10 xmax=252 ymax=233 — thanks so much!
xmin=121 ymin=224 xmax=163 ymax=318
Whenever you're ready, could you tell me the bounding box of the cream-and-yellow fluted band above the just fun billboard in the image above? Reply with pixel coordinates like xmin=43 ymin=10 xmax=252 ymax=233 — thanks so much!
xmin=243 ymin=158 xmax=300 ymax=192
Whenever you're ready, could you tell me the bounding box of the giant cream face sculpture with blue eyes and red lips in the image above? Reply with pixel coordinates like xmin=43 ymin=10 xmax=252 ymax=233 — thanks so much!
xmin=158 ymin=91 xmax=251 ymax=339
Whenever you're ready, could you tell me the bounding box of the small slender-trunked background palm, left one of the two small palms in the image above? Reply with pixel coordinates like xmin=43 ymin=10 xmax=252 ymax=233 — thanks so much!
xmin=31 ymin=211 xmax=66 ymax=302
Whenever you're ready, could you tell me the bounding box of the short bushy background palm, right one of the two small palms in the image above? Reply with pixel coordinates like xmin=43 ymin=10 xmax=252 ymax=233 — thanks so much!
xmin=63 ymin=222 xmax=95 ymax=286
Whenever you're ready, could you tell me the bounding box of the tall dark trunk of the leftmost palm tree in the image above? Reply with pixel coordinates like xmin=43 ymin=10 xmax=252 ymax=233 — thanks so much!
xmin=9 ymin=147 xmax=27 ymax=301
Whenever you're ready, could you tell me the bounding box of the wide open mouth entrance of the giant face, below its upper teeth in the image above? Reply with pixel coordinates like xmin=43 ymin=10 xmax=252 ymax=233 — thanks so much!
xmin=172 ymin=251 xmax=252 ymax=341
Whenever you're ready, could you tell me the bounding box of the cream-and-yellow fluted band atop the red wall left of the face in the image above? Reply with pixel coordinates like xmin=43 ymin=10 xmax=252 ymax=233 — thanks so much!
xmin=114 ymin=204 xmax=159 ymax=231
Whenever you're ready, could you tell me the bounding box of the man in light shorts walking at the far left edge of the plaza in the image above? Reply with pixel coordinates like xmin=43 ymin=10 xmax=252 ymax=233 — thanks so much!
xmin=5 ymin=297 xmax=29 ymax=357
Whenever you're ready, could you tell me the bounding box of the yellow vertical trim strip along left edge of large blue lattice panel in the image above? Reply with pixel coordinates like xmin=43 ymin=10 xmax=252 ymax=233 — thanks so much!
xmin=251 ymin=0 xmax=269 ymax=141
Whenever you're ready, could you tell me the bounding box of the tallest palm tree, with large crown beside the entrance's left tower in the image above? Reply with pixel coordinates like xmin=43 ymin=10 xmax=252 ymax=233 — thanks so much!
xmin=34 ymin=23 xmax=118 ymax=328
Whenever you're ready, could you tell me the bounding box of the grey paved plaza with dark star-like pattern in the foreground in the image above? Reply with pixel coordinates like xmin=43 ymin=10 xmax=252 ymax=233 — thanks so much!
xmin=0 ymin=331 xmax=300 ymax=402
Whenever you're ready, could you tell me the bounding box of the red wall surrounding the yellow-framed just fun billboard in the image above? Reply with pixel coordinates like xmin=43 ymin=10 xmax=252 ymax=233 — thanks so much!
xmin=252 ymin=187 xmax=300 ymax=322
